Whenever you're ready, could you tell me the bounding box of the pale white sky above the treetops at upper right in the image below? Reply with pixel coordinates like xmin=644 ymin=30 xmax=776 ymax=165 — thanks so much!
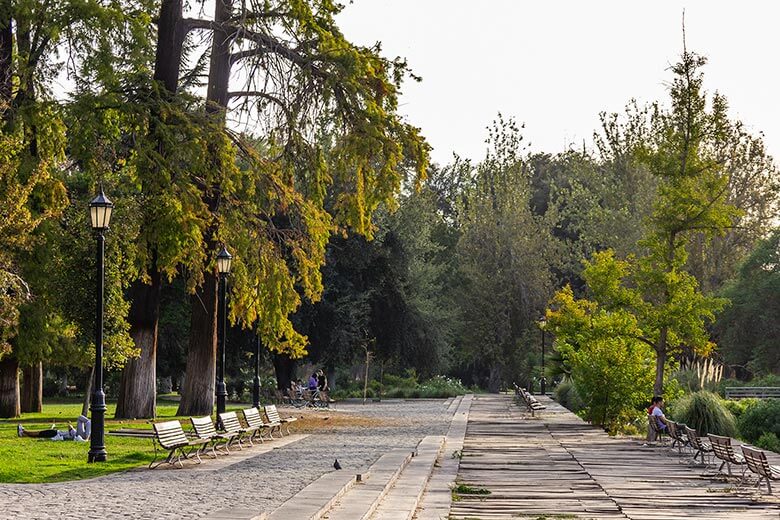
xmin=338 ymin=0 xmax=780 ymax=167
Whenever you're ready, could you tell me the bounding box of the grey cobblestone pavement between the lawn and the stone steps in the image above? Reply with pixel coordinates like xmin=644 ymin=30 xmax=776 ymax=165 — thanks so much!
xmin=0 ymin=399 xmax=454 ymax=520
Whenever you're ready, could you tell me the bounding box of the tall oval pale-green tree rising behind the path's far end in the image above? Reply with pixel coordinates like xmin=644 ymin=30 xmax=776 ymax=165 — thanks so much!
xmin=458 ymin=120 xmax=553 ymax=391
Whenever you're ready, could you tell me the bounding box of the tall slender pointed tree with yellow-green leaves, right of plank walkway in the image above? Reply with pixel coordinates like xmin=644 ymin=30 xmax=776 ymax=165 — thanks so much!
xmin=635 ymin=50 xmax=739 ymax=395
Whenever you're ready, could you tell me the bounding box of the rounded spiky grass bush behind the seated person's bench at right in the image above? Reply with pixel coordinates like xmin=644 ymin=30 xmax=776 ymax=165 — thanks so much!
xmin=674 ymin=391 xmax=737 ymax=437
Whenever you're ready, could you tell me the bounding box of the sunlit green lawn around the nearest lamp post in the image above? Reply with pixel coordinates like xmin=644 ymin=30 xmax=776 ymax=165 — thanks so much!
xmin=0 ymin=399 xmax=247 ymax=483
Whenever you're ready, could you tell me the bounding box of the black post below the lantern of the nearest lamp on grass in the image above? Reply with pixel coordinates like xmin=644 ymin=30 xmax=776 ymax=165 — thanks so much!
xmin=87 ymin=231 xmax=108 ymax=462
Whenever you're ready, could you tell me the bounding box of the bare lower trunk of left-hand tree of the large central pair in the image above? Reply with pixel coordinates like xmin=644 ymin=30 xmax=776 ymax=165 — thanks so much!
xmin=114 ymin=267 xmax=162 ymax=419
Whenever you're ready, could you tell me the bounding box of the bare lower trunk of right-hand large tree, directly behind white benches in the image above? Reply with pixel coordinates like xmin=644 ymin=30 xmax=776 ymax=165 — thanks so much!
xmin=176 ymin=272 xmax=217 ymax=415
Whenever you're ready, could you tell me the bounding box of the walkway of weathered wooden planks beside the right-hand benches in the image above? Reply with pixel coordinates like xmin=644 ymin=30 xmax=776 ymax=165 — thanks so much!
xmin=450 ymin=395 xmax=780 ymax=520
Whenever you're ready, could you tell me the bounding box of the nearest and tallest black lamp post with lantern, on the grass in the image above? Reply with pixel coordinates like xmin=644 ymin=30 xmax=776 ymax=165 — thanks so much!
xmin=87 ymin=189 xmax=114 ymax=462
